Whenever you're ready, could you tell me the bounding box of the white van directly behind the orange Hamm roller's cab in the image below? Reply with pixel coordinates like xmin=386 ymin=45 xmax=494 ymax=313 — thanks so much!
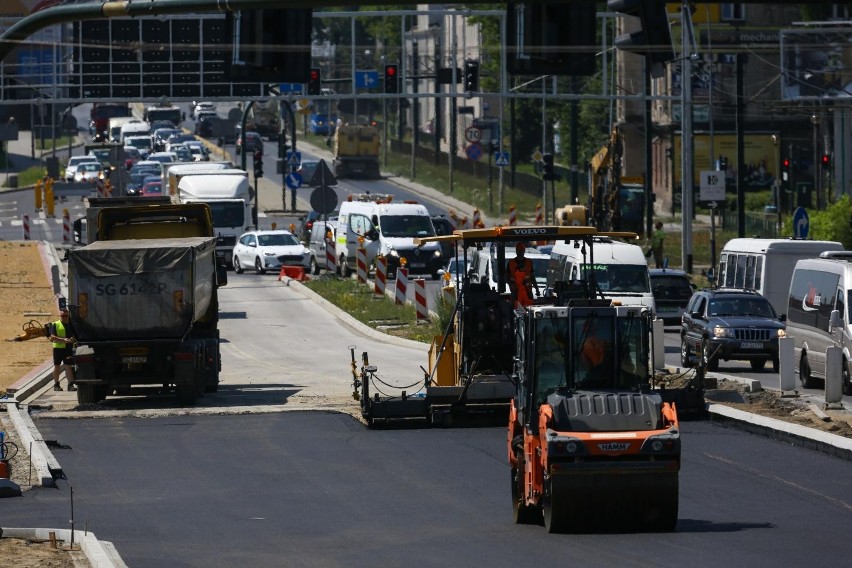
xmin=547 ymin=237 xmax=657 ymax=315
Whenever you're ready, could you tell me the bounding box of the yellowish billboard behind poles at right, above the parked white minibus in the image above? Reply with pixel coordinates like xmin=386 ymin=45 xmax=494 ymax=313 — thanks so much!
xmin=674 ymin=133 xmax=779 ymax=191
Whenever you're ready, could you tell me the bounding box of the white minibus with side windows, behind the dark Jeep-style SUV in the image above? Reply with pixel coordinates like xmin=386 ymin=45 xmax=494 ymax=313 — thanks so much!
xmin=714 ymin=238 xmax=843 ymax=314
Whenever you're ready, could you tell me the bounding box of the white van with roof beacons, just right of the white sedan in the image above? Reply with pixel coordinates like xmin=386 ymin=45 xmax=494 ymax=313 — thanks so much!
xmin=335 ymin=195 xmax=446 ymax=279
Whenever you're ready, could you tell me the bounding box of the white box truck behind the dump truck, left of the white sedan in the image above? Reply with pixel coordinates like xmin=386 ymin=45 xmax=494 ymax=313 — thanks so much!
xmin=177 ymin=169 xmax=252 ymax=266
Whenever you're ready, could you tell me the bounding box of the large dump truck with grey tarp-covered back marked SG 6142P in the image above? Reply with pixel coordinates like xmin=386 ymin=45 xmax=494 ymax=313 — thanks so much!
xmin=68 ymin=203 xmax=227 ymax=405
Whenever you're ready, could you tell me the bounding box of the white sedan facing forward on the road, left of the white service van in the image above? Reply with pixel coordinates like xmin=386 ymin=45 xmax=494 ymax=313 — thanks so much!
xmin=232 ymin=230 xmax=311 ymax=274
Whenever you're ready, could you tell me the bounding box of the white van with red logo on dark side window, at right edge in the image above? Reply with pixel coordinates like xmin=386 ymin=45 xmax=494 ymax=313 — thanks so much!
xmin=787 ymin=252 xmax=852 ymax=395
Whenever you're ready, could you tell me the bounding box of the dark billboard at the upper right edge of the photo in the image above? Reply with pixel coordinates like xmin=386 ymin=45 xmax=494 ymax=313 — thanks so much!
xmin=781 ymin=27 xmax=852 ymax=101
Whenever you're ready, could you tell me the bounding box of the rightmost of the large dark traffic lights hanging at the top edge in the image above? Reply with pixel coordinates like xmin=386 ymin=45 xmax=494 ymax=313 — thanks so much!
xmin=606 ymin=0 xmax=674 ymax=78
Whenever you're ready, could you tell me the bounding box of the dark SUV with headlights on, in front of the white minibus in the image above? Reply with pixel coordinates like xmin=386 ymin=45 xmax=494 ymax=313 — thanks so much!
xmin=680 ymin=290 xmax=786 ymax=372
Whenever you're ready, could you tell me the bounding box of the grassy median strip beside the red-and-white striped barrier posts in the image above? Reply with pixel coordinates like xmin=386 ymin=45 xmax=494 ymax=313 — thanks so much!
xmin=305 ymin=274 xmax=452 ymax=344
